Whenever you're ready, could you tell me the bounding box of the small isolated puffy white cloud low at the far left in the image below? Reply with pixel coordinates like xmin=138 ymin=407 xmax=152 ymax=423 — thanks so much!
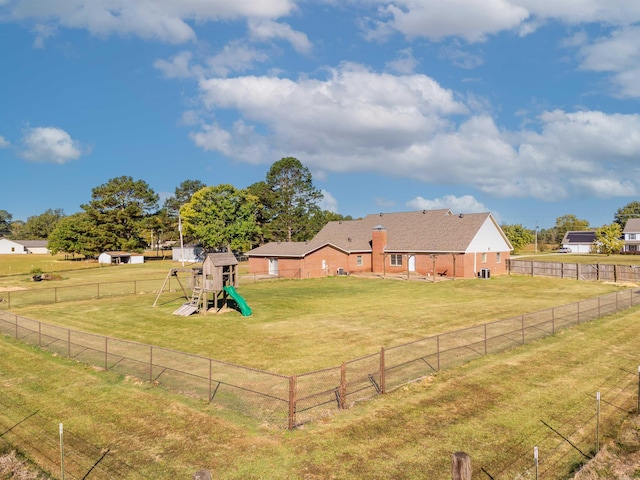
xmin=21 ymin=127 xmax=88 ymax=164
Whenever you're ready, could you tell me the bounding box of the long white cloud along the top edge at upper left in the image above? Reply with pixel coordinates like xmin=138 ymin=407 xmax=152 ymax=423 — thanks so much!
xmin=5 ymin=0 xmax=295 ymax=43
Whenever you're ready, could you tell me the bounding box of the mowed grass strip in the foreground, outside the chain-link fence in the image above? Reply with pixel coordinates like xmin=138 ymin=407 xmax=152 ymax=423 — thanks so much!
xmin=0 ymin=294 xmax=640 ymax=480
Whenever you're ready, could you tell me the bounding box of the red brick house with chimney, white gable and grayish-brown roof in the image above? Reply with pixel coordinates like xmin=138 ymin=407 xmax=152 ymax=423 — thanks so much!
xmin=246 ymin=209 xmax=513 ymax=278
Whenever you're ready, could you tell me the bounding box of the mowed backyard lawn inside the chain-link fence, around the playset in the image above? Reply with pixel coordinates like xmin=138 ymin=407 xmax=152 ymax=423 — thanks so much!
xmin=3 ymin=265 xmax=621 ymax=375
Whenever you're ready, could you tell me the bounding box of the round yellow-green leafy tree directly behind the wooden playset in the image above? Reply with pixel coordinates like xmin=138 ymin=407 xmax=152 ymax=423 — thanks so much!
xmin=180 ymin=184 xmax=260 ymax=251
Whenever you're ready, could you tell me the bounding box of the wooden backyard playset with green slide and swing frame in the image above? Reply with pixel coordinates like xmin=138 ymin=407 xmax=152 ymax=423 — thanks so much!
xmin=153 ymin=252 xmax=253 ymax=317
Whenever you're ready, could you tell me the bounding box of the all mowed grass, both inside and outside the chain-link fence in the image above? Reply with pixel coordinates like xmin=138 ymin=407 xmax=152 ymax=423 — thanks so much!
xmin=0 ymin=255 xmax=640 ymax=479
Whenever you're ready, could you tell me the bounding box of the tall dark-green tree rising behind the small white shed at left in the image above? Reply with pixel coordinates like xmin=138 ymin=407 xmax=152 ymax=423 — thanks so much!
xmin=81 ymin=176 xmax=158 ymax=251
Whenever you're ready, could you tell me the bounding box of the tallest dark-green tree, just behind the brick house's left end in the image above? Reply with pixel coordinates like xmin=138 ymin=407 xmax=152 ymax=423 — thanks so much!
xmin=266 ymin=157 xmax=322 ymax=242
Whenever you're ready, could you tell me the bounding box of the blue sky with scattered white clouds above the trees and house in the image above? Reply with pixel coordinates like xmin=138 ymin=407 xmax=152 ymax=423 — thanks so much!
xmin=0 ymin=0 xmax=640 ymax=228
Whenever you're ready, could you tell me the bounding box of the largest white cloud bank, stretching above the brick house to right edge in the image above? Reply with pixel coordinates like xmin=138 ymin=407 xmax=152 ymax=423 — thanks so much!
xmin=192 ymin=64 xmax=640 ymax=200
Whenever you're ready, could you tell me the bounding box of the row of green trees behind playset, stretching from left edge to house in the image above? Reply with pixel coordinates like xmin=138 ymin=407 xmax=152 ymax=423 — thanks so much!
xmin=0 ymin=157 xmax=351 ymax=258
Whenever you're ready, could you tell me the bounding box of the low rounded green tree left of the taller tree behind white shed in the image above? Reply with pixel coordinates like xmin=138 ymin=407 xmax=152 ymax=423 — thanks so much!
xmin=48 ymin=212 xmax=103 ymax=258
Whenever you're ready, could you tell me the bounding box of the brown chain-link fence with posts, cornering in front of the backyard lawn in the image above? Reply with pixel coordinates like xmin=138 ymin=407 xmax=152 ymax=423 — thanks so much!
xmin=0 ymin=280 xmax=640 ymax=429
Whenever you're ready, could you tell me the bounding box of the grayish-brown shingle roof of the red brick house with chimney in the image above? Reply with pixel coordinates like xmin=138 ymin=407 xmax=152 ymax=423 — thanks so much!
xmin=247 ymin=209 xmax=500 ymax=257
